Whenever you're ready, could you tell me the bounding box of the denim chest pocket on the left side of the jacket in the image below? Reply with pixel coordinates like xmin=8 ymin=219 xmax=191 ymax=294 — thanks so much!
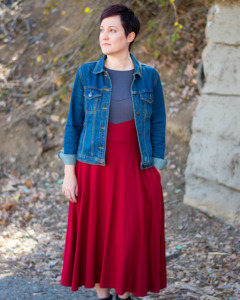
xmin=84 ymin=88 xmax=102 ymax=113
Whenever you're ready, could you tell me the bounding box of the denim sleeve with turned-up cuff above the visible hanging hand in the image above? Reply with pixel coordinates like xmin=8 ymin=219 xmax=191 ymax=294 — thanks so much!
xmin=58 ymin=67 xmax=84 ymax=165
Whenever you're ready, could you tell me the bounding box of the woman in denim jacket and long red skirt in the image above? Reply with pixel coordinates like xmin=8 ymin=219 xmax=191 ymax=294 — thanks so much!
xmin=59 ymin=4 xmax=167 ymax=299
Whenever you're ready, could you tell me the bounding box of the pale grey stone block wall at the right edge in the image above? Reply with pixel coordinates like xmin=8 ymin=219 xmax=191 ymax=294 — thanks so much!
xmin=184 ymin=4 xmax=240 ymax=225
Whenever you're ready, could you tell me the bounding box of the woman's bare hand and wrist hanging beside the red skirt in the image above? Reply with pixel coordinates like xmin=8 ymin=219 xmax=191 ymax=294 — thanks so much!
xmin=62 ymin=165 xmax=78 ymax=203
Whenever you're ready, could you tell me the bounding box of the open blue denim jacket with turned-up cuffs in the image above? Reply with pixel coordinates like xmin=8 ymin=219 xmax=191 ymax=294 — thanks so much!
xmin=58 ymin=52 xmax=168 ymax=169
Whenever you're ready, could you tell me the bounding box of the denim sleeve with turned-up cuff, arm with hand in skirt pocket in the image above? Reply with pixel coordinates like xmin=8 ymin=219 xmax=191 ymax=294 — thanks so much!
xmin=150 ymin=70 xmax=168 ymax=170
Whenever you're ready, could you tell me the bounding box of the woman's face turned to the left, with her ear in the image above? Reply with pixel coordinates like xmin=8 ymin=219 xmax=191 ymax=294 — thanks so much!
xmin=99 ymin=15 xmax=135 ymax=55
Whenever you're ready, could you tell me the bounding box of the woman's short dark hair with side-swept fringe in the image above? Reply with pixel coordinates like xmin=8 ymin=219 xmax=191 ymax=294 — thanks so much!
xmin=100 ymin=4 xmax=140 ymax=51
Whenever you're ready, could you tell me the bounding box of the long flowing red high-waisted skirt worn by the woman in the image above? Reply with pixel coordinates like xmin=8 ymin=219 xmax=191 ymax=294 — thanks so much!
xmin=61 ymin=120 xmax=167 ymax=297
